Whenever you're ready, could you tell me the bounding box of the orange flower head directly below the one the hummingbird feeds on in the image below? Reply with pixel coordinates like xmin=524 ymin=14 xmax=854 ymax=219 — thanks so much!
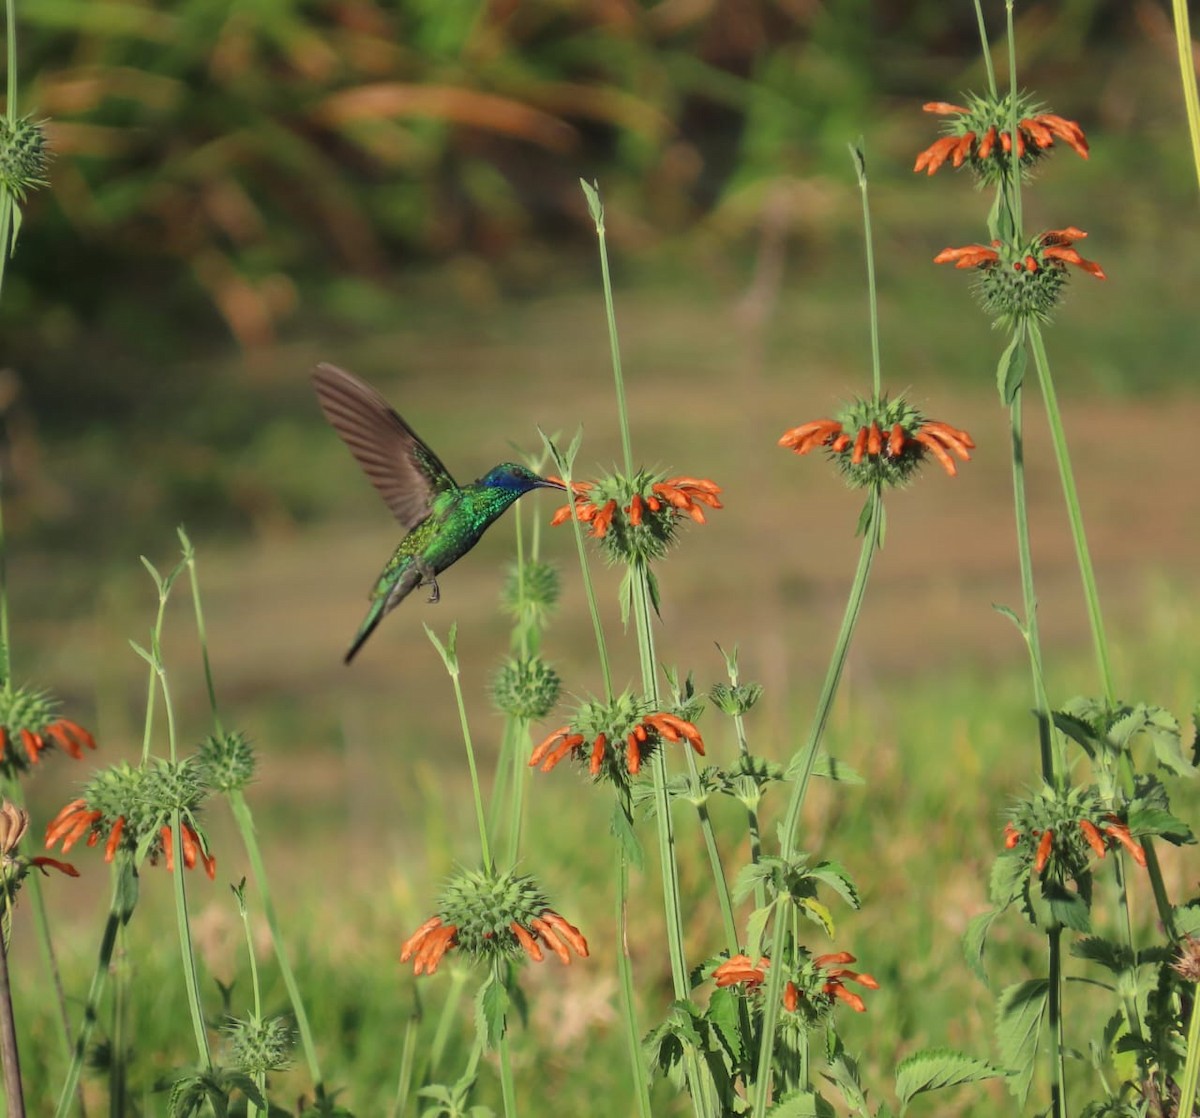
xmin=529 ymin=693 xmax=704 ymax=785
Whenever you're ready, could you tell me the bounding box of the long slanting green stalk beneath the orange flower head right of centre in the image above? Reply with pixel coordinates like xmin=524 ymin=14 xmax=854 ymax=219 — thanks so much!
xmin=752 ymin=488 xmax=883 ymax=1118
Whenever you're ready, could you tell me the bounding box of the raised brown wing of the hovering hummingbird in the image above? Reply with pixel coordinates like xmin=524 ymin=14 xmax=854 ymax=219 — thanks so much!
xmin=312 ymin=363 xmax=458 ymax=531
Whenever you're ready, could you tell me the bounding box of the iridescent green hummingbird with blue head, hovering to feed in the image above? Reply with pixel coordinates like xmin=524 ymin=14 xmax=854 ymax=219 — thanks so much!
xmin=313 ymin=363 xmax=565 ymax=663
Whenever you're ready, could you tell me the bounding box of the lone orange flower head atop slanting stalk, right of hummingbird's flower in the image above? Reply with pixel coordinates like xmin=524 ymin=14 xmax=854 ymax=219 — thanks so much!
xmin=779 ymin=396 xmax=974 ymax=487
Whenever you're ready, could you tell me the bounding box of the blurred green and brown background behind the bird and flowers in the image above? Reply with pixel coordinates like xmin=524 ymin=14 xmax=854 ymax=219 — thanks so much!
xmin=7 ymin=0 xmax=1200 ymax=1108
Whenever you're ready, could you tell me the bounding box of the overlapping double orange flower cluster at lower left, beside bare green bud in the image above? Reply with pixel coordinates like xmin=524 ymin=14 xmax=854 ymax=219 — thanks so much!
xmin=46 ymin=761 xmax=217 ymax=878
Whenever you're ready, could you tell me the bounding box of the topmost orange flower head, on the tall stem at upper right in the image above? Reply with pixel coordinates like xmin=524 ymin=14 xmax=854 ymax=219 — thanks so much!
xmin=913 ymin=94 xmax=1087 ymax=182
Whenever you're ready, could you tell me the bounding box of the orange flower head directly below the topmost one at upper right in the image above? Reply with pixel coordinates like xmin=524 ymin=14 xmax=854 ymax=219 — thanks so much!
xmin=934 ymin=226 xmax=1108 ymax=325
